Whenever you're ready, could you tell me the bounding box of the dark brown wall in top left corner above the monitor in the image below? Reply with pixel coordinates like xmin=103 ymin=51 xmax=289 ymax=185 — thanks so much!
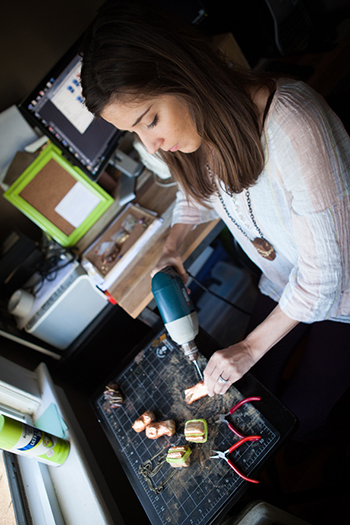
xmin=0 ymin=0 xmax=103 ymax=111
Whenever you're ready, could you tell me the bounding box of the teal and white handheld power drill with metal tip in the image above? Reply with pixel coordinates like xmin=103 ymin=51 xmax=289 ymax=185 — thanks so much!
xmin=152 ymin=266 xmax=203 ymax=381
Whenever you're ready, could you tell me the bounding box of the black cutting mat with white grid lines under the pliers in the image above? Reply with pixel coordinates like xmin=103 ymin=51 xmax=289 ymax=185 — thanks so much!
xmin=95 ymin=331 xmax=280 ymax=525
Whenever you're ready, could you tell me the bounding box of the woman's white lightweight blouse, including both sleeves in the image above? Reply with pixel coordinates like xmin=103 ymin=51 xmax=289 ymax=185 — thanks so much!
xmin=172 ymin=79 xmax=350 ymax=323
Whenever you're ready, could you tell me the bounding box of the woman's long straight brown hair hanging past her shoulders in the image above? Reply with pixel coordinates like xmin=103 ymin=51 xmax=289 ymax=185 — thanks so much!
xmin=81 ymin=0 xmax=275 ymax=201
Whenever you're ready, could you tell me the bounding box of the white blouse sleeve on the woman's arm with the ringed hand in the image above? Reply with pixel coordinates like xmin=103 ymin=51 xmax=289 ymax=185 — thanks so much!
xmin=279 ymin=84 xmax=350 ymax=323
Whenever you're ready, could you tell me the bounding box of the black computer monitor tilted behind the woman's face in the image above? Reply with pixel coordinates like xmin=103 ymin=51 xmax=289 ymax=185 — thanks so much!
xmin=19 ymin=37 xmax=122 ymax=180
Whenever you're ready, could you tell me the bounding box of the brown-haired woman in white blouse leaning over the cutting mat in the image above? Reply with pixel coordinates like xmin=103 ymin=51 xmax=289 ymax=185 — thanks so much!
xmin=82 ymin=2 xmax=350 ymax=442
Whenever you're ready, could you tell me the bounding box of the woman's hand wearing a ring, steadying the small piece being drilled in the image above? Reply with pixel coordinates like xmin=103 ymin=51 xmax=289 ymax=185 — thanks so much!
xmin=204 ymin=340 xmax=255 ymax=396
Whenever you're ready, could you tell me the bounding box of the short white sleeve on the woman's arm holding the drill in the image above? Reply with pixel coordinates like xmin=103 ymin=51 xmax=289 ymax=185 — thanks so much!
xmin=172 ymin=186 xmax=219 ymax=226
